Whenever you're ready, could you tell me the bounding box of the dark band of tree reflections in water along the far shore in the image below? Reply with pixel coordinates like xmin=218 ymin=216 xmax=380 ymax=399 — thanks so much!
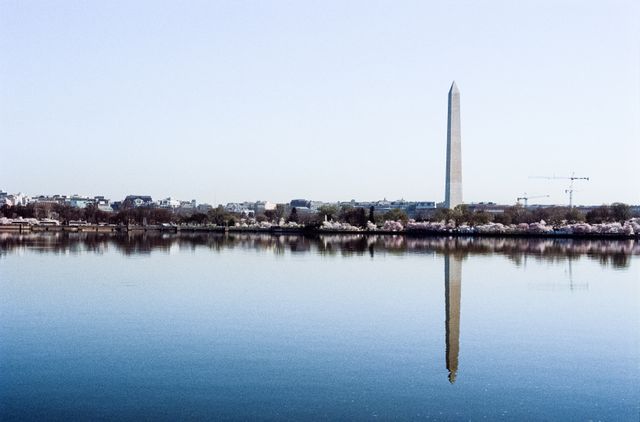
xmin=0 ymin=232 xmax=640 ymax=268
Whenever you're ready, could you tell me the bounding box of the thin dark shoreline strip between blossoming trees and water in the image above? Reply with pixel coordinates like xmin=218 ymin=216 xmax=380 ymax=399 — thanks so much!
xmin=0 ymin=224 xmax=640 ymax=240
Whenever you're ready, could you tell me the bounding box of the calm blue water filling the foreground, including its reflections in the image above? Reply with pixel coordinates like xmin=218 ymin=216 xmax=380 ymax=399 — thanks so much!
xmin=0 ymin=233 xmax=640 ymax=421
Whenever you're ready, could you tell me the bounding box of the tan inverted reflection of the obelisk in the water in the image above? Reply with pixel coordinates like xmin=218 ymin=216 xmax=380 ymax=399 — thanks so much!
xmin=444 ymin=253 xmax=462 ymax=384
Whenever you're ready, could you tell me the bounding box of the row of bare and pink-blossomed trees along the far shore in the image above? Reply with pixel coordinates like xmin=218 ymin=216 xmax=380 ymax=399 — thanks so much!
xmin=0 ymin=204 xmax=640 ymax=238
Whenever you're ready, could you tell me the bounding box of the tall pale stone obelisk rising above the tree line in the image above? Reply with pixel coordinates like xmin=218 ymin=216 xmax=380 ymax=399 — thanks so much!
xmin=444 ymin=81 xmax=462 ymax=208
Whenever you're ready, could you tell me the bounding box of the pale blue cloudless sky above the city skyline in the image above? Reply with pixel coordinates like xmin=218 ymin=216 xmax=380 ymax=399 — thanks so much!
xmin=0 ymin=0 xmax=640 ymax=204
